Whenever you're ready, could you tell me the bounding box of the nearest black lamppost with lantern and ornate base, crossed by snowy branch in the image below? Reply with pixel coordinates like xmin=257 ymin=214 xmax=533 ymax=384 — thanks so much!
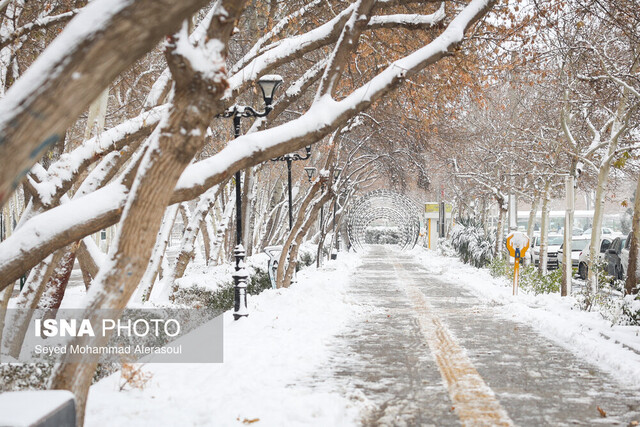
xmin=217 ymin=75 xmax=283 ymax=320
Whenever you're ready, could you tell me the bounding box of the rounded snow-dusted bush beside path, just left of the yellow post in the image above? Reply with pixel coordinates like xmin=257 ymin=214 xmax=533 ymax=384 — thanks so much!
xmin=451 ymin=220 xmax=494 ymax=268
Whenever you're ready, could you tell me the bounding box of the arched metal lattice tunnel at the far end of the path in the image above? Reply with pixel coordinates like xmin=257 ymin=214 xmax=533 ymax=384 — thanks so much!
xmin=347 ymin=190 xmax=420 ymax=251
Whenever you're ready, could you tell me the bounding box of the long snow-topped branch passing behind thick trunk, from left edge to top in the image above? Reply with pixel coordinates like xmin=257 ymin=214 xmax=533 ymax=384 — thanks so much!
xmin=0 ymin=0 xmax=494 ymax=287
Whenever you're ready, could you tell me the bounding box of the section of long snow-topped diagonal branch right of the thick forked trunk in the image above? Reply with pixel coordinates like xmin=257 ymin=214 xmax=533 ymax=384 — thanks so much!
xmin=173 ymin=0 xmax=494 ymax=202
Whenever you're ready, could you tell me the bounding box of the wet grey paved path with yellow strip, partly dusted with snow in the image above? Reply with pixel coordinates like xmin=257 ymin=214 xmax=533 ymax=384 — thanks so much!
xmin=316 ymin=247 xmax=640 ymax=426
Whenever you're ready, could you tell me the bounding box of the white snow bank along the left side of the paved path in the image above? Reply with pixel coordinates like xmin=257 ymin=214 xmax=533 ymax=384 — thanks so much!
xmin=86 ymin=254 xmax=360 ymax=426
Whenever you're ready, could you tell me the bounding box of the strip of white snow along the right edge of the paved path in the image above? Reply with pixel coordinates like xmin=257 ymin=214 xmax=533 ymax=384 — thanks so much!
xmin=412 ymin=248 xmax=640 ymax=387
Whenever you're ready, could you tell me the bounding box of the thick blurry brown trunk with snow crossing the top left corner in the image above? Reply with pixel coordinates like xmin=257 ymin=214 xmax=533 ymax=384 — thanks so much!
xmin=0 ymin=0 xmax=208 ymax=204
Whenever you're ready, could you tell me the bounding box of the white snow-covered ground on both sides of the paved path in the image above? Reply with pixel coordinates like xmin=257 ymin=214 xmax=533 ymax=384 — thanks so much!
xmin=72 ymin=248 xmax=640 ymax=426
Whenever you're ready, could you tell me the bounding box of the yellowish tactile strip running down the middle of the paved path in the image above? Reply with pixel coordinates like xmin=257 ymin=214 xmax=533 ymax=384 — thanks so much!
xmin=394 ymin=263 xmax=514 ymax=426
